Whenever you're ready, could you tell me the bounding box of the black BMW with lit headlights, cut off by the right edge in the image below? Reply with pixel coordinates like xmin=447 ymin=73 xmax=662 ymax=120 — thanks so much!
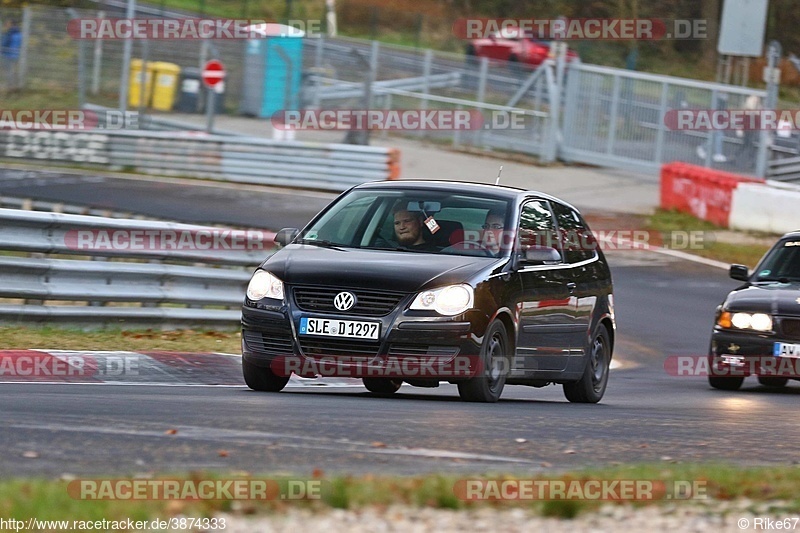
xmin=708 ymin=231 xmax=800 ymax=390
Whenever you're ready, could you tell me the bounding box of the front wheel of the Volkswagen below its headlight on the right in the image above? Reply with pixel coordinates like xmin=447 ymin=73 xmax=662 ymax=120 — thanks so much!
xmin=458 ymin=320 xmax=510 ymax=403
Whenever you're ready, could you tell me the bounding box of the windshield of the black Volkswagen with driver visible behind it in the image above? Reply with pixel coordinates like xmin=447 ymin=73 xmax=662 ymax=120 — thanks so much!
xmin=295 ymin=189 xmax=510 ymax=257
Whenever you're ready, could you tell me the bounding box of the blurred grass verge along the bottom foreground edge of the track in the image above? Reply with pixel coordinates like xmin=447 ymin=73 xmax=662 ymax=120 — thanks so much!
xmin=0 ymin=464 xmax=800 ymax=520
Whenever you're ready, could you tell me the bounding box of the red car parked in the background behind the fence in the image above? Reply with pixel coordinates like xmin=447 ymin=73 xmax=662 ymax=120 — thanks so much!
xmin=466 ymin=27 xmax=578 ymax=68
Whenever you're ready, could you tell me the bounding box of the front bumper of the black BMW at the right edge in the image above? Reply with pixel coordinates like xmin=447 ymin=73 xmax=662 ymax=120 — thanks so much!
xmin=708 ymin=328 xmax=800 ymax=379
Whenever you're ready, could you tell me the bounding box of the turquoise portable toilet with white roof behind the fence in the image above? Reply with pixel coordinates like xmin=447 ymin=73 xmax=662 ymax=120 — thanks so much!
xmin=239 ymin=23 xmax=305 ymax=118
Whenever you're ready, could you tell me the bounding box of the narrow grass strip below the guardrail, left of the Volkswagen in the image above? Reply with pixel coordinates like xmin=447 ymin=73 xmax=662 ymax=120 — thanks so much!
xmin=0 ymin=326 xmax=241 ymax=354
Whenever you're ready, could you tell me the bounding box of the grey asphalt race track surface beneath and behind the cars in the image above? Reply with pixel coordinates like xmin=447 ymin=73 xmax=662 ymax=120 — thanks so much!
xmin=0 ymin=168 xmax=800 ymax=476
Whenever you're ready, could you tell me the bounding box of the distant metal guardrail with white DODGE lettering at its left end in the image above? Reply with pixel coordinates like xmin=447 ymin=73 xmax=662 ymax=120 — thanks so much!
xmin=0 ymin=130 xmax=400 ymax=191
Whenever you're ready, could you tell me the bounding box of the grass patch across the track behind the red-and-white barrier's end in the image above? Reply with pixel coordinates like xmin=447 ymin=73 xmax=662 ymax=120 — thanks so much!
xmin=646 ymin=209 xmax=777 ymax=268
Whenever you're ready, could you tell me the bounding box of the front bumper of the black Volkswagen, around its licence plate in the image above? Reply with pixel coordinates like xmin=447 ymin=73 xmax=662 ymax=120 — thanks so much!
xmin=242 ymin=296 xmax=488 ymax=381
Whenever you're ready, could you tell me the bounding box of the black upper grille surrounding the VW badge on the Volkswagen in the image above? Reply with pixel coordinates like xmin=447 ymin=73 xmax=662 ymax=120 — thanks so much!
xmin=294 ymin=287 xmax=405 ymax=316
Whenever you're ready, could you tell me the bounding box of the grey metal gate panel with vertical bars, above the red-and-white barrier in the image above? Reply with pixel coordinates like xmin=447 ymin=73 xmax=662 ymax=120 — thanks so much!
xmin=559 ymin=64 xmax=766 ymax=174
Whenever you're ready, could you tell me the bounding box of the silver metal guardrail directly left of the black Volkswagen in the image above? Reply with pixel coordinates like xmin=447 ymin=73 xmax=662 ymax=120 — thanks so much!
xmin=0 ymin=209 xmax=274 ymax=327
